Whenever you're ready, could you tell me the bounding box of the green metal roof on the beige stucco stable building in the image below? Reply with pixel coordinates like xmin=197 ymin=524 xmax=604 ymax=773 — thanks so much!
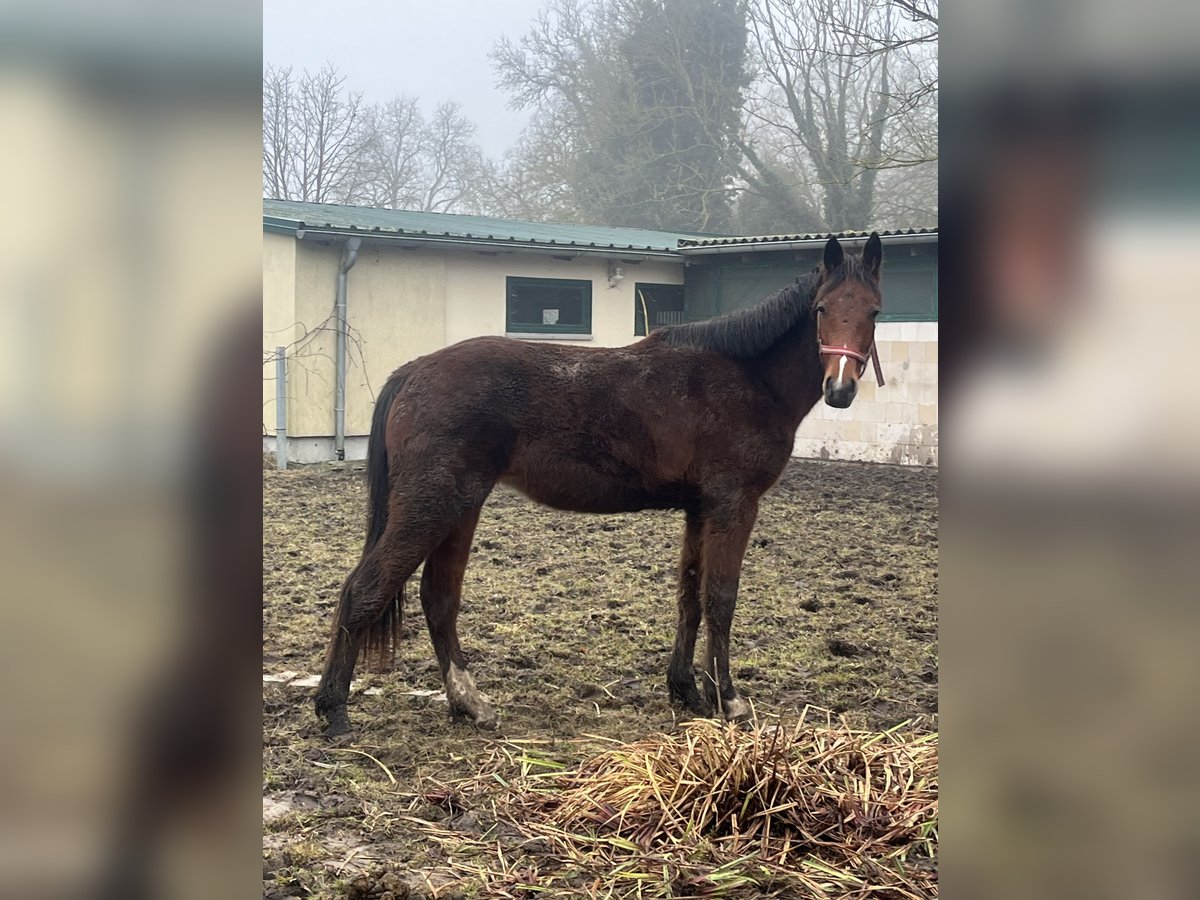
xmin=263 ymin=199 xmax=715 ymax=256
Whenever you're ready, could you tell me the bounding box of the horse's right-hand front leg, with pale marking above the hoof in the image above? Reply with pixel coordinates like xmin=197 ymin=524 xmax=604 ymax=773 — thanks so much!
xmin=700 ymin=498 xmax=758 ymax=721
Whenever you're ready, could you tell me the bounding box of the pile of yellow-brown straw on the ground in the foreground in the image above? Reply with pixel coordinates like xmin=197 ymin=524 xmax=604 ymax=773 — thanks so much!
xmin=422 ymin=710 xmax=937 ymax=900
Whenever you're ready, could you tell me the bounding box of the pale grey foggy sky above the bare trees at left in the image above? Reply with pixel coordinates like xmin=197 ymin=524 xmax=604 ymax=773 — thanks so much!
xmin=263 ymin=0 xmax=545 ymax=157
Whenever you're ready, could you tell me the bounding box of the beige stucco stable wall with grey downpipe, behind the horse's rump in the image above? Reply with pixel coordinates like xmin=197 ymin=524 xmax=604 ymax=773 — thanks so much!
xmin=263 ymin=234 xmax=683 ymax=438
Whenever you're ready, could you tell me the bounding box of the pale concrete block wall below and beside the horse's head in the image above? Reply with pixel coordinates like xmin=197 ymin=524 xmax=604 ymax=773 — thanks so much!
xmin=794 ymin=322 xmax=937 ymax=466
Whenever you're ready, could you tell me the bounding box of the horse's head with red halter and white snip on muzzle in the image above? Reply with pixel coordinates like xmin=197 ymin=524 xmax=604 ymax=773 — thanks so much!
xmin=812 ymin=233 xmax=883 ymax=409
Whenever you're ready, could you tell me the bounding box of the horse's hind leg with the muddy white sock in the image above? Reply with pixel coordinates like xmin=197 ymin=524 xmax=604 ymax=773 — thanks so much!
xmin=421 ymin=509 xmax=496 ymax=728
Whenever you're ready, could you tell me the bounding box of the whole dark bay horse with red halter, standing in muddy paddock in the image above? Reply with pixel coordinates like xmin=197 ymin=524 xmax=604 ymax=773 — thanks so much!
xmin=316 ymin=233 xmax=883 ymax=736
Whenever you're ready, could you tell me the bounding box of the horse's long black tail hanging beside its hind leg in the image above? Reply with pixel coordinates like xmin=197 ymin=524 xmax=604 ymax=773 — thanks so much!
xmin=362 ymin=368 xmax=408 ymax=672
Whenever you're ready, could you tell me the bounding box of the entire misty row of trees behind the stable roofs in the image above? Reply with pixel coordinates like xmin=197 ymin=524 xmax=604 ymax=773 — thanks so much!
xmin=263 ymin=0 xmax=938 ymax=233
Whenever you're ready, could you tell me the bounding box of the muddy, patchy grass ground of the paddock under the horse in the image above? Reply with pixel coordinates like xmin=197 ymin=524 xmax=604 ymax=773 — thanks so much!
xmin=263 ymin=461 xmax=937 ymax=900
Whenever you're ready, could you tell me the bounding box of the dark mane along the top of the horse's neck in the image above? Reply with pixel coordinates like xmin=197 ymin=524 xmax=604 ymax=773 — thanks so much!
xmin=654 ymin=271 xmax=817 ymax=359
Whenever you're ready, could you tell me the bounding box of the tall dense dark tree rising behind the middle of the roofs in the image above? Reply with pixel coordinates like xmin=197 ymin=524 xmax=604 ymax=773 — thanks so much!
xmin=493 ymin=0 xmax=748 ymax=230
